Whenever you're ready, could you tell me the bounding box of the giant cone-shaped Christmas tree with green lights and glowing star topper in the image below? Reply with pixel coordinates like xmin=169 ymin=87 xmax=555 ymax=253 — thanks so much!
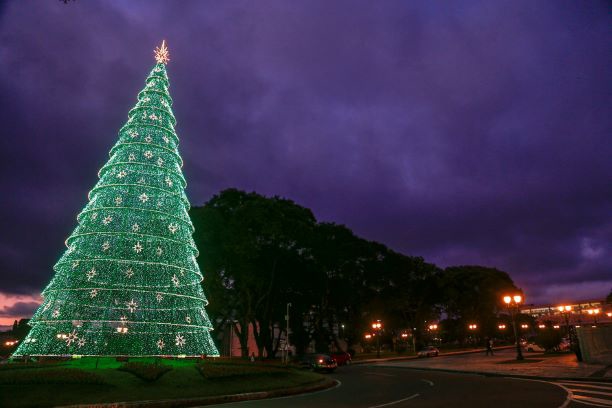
xmin=14 ymin=43 xmax=219 ymax=356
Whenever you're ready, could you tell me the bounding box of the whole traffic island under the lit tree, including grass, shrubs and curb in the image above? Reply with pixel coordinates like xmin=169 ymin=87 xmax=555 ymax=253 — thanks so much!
xmin=0 ymin=359 xmax=335 ymax=408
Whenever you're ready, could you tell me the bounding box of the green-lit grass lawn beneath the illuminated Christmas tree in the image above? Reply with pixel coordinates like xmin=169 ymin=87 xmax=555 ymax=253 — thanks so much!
xmin=0 ymin=358 xmax=324 ymax=408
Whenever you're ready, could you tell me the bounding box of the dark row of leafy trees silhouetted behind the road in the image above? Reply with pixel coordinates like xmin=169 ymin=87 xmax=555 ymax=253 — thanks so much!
xmin=190 ymin=189 xmax=518 ymax=356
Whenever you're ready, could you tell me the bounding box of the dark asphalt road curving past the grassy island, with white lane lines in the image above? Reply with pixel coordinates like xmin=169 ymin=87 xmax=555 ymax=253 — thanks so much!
xmin=203 ymin=365 xmax=572 ymax=408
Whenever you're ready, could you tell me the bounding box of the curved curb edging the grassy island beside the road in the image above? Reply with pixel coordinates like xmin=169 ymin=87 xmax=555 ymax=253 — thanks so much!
xmin=60 ymin=379 xmax=338 ymax=408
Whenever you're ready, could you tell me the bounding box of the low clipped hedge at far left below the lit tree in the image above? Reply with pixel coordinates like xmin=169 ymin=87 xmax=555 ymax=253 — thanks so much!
xmin=0 ymin=368 xmax=106 ymax=385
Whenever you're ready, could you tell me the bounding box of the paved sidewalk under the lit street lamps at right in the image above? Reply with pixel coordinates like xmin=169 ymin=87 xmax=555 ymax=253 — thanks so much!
xmin=376 ymin=349 xmax=612 ymax=381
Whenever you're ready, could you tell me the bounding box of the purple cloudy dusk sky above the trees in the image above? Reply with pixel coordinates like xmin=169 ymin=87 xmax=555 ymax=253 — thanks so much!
xmin=0 ymin=0 xmax=612 ymax=324
